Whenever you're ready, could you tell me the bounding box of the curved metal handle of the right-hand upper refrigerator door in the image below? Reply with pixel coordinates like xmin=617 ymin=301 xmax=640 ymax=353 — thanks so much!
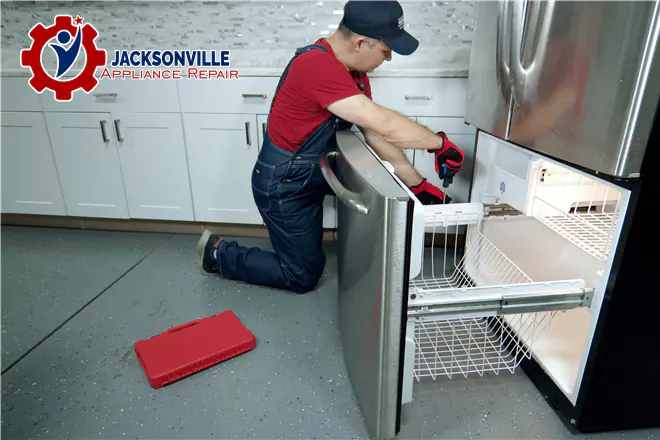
xmin=507 ymin=0 xmax=555 ymax=107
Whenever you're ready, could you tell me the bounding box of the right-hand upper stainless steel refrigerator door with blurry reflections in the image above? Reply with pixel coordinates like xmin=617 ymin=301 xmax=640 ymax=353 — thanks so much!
xmin=508 ymin=1 xmax=660 ymax=177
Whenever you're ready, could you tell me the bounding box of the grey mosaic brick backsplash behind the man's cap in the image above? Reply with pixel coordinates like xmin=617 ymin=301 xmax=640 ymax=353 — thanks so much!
xmin=1 ymin=0 xmax=475 ymax=68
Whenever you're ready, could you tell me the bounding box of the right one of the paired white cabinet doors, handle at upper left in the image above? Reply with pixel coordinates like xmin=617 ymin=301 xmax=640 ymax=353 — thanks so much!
xmin=112 ymin=112 xmax=194 ymax=221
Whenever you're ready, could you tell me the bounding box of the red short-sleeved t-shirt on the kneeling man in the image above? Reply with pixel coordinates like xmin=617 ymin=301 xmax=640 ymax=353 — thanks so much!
xmin=268 ymin=38 xmax=371 ymax=151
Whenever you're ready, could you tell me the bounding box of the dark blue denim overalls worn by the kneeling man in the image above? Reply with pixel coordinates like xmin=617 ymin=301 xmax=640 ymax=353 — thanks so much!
xmin=218 ymin=45 xmax=362 ymax=293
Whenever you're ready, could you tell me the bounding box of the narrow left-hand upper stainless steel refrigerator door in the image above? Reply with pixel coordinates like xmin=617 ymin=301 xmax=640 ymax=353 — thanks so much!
xmin=465 ymin=1 xmax=512 ymax=139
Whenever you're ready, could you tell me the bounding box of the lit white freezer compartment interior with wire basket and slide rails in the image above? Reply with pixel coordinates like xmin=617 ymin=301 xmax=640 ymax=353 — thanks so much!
xmin=403 ymin=132 xmax=629 ymax=404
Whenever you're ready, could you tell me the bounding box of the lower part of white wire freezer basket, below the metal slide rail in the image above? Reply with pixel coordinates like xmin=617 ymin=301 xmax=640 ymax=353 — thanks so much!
xmin=413 ymin=312 xmax=556 ymax=382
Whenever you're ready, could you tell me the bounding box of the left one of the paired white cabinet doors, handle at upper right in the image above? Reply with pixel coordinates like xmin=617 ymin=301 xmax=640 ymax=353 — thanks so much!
xmin=46 ymin=113 xmax=128 ymax=218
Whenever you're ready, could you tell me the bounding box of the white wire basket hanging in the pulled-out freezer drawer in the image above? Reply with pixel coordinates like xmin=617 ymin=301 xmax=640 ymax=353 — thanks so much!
xmin=409 ymin=206 xmax=556 ymax=381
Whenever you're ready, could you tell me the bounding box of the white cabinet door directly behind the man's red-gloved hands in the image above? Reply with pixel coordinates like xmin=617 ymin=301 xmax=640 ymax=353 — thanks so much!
xmin=415 ymin=117 xmax=476 ymax=203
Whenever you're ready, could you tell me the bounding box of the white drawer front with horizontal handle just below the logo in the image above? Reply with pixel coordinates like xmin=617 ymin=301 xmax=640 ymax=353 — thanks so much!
xmin=40 ymin=79 xmax=180 ymax=113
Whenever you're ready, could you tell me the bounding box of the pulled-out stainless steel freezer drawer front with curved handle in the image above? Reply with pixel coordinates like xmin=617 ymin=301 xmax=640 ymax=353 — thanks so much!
xmin=321 ymin=132 xmax=413 ymax=439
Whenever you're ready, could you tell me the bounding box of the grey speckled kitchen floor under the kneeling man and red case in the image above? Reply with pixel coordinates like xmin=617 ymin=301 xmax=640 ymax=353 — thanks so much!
xmin=2 ymin=226 xmax=660 ymax=439
